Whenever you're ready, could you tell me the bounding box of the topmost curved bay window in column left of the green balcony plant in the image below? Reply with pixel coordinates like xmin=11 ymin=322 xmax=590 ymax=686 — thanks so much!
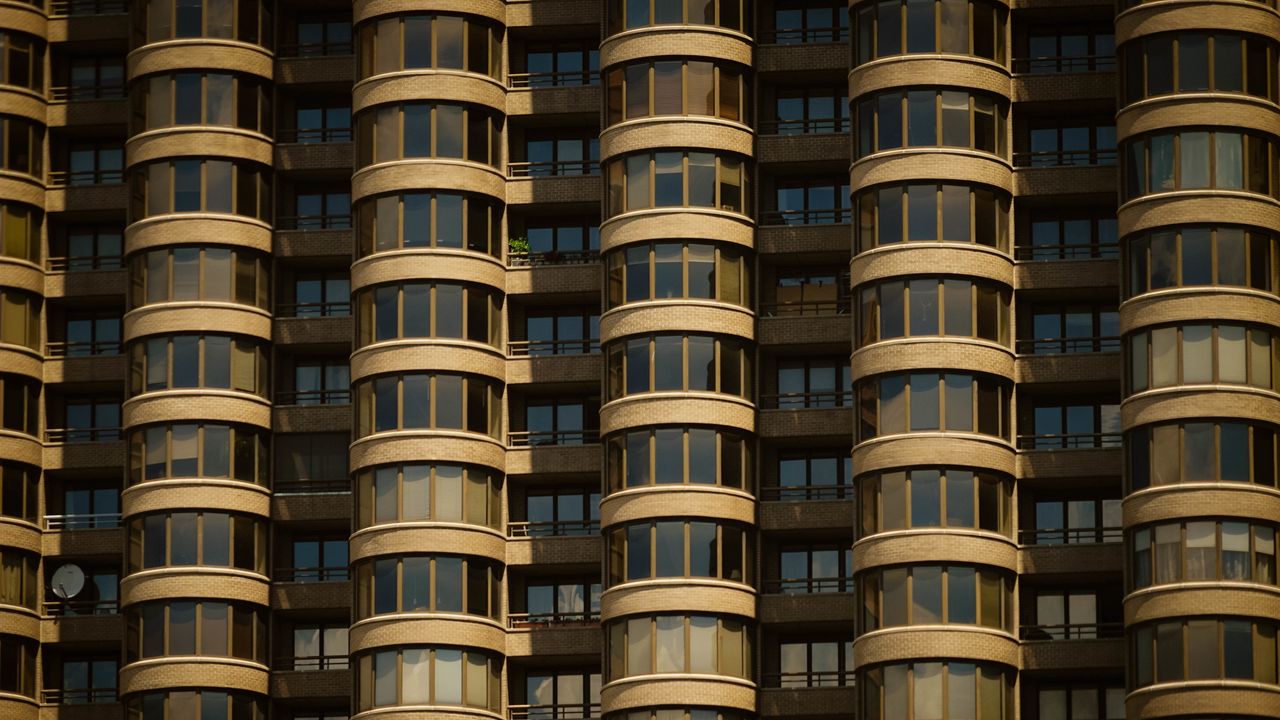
xmin=356 ymin=14 xmax=502 ymax=81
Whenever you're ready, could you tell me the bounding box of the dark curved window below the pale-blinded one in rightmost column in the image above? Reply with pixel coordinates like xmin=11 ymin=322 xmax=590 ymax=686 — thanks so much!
xmin=1124 ymin=420 xmax=1277 ymax=492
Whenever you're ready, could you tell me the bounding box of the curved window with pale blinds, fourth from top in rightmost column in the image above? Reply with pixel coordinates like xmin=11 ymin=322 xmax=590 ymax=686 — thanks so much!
xmin=1126 ymin=324 xmax=1280 ymax=393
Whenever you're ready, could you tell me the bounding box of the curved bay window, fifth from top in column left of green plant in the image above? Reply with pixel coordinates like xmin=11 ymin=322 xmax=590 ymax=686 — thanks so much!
xmin=355 ymin=373 xmax=502 ymax=438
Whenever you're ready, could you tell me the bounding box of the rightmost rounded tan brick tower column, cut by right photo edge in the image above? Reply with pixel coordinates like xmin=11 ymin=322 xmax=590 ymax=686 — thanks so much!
xmin=1116 ymin=0 xmax=1280 ymax=719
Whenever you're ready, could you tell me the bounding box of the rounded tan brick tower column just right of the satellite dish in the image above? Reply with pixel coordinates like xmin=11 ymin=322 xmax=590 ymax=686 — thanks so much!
xmin=119 ymin=0 xmax=275 ymax=712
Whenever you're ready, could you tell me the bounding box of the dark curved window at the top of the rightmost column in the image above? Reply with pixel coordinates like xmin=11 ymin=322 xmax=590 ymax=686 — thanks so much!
xmin=1120 ymin=32 xmax=1276 ymax=105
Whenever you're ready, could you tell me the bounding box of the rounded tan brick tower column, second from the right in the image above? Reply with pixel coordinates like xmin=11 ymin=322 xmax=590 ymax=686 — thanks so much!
xmin=849 ymin=0 xmax=1019 ymax=720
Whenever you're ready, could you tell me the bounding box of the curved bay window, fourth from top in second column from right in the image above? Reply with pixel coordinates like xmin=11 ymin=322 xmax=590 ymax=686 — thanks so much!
xmin=854 ymin=278 xmax=1010 ymax=347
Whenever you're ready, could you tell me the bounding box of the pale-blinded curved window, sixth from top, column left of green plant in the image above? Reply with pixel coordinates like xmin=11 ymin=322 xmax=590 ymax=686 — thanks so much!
xmin=356 ymin=465 xmax=502 ymax=528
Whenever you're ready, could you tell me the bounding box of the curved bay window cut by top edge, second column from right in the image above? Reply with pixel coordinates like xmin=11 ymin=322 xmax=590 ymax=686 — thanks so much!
xmin=852 ymin=0 xmax=1009 ymax=65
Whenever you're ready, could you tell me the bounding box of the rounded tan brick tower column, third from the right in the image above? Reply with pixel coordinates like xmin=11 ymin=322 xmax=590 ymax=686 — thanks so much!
xmin=600 ymin=0 xmax=756 ymax=717
